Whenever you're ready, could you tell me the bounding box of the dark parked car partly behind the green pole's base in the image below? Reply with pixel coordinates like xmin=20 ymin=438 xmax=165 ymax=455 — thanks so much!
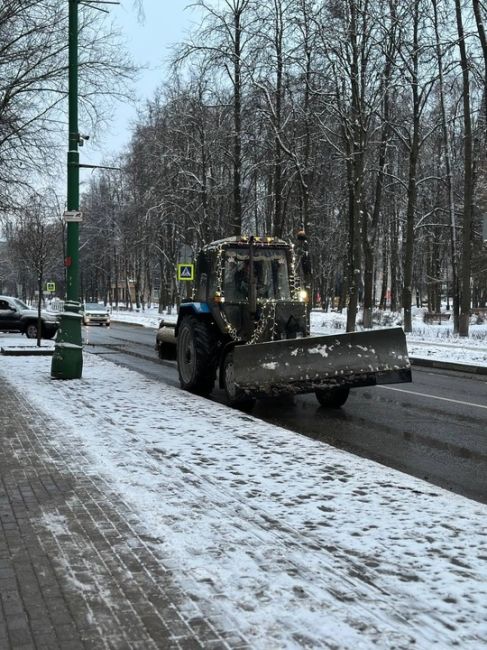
xmin=0 ymin=296 xmax=59 ymax=339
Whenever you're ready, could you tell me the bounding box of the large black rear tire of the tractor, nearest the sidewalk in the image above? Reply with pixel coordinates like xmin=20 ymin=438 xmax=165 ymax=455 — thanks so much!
xmin=176 ymin=316 xmax=216 ymax=397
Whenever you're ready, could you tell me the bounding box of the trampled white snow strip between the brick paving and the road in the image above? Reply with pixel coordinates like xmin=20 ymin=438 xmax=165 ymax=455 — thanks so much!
xmin=0 ymin=313 xmax=487 ymax=650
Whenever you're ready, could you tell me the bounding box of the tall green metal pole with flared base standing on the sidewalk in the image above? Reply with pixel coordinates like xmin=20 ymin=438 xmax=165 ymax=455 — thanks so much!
xmin=51 ymin=0 xmax=83 ymax=379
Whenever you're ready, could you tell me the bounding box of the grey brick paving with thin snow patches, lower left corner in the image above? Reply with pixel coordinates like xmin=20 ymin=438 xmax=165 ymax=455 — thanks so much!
xmin=0 ymin=379 xmax=249 ymax=650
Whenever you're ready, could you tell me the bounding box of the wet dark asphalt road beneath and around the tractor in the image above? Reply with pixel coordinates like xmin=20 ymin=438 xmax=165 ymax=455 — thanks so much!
xmin=83 ymin=323 xmax=487 ymax=503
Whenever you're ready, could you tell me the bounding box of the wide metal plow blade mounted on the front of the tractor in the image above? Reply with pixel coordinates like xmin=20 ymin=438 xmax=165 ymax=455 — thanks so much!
xmin=233 ymin=327 xmax=411 ymax=395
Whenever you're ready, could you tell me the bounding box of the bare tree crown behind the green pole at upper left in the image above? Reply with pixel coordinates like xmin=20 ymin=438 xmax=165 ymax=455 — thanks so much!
xmin=0 ymin=0 xmax=135 ymax=210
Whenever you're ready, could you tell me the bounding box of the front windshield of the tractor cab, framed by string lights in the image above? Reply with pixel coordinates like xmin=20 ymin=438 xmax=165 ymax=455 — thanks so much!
xmin=223 ymin=248 xmax=290 ymax=302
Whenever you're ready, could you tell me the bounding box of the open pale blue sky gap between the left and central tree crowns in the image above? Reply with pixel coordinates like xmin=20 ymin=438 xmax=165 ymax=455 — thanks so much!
xmin=80 ymin=0 xmax=196 ymax=164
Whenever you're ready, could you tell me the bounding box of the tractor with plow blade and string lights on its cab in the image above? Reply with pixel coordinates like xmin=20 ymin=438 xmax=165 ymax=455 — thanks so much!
xmin=156 ymin=236 xmax=411 ymax=410
